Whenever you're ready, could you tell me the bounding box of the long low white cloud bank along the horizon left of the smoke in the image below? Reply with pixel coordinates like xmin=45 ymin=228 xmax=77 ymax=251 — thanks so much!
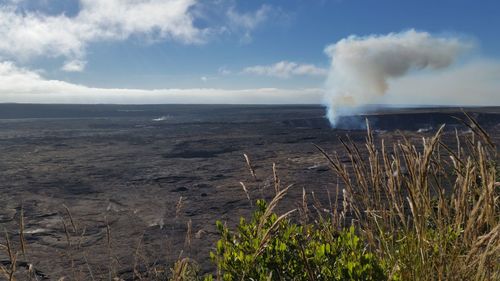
xmin=0 ymin=62 xmax=323 ymax=104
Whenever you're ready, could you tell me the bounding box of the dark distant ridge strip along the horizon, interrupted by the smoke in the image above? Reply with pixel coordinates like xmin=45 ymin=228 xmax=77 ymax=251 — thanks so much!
xmin=0 ymin=103 xmax=500 ymax=119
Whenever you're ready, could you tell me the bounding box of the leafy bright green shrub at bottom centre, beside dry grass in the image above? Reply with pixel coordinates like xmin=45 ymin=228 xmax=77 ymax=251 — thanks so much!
xmin=207 ymin=200 xmax=387 ymax=281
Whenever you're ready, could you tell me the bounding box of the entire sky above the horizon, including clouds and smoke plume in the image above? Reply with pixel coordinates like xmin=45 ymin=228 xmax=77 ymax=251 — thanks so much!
xmin=0 ymin=0 xmax=500 ymax=105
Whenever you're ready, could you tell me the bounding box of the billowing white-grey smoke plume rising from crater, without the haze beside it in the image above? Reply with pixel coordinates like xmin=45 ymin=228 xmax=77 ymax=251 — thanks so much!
xmin=325 ymin=30 xmax=472 ymax=126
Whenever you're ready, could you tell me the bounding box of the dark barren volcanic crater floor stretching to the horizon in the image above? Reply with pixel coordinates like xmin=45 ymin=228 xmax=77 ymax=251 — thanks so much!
xmin=0 ymin=105 xmax=500 ymax=280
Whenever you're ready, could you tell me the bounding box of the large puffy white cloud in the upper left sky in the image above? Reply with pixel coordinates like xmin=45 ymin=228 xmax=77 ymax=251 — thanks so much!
xmin=0 ymin=0 xmax=204 ymax=70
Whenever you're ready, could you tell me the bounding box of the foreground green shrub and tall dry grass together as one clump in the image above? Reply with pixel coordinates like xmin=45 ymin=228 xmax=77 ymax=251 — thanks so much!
xmin=205 ymin=114 xmax=500 ymax=280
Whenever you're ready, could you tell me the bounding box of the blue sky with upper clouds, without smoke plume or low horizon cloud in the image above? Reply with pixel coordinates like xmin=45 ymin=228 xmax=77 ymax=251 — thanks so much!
xmin=0 ymin=0 xmax=500 ymax=103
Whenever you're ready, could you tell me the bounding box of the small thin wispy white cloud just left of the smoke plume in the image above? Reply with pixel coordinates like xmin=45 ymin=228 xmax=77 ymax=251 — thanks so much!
xmin=243 ymin=61 xmax=328 ymax=78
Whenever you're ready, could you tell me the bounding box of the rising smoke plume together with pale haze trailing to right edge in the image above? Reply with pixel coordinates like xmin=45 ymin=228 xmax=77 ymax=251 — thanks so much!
xmin=324 ymin=30 xmax=500 ymax=125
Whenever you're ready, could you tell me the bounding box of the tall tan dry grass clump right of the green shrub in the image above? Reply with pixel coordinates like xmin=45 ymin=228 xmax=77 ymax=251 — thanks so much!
xmin=318 ymin=119 xmax=500 ymax=280
